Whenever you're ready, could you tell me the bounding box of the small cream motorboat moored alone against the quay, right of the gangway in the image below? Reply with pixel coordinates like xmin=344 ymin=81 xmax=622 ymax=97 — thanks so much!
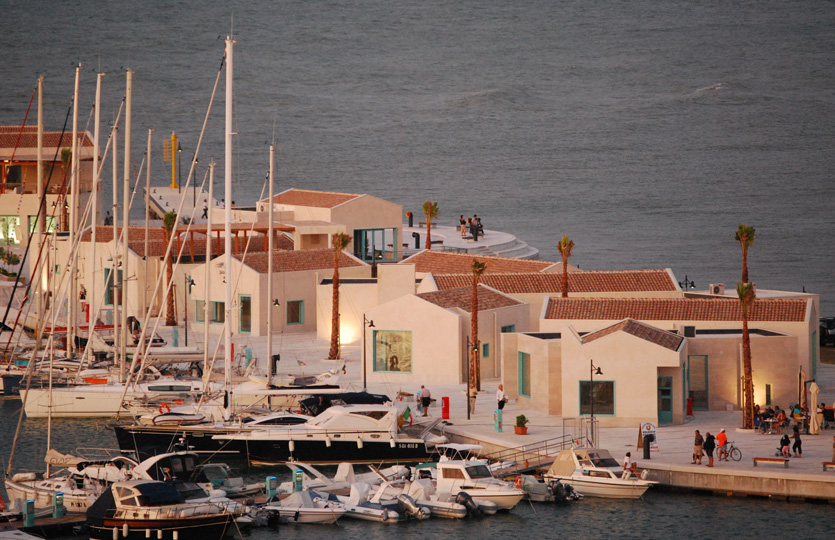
xmin=542 ymin=448 xmax=658 ymax=499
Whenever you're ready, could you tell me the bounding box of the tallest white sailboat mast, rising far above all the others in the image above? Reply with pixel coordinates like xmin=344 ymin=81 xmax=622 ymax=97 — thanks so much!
xmin=223 ymin=36 xmax=235 ymax=420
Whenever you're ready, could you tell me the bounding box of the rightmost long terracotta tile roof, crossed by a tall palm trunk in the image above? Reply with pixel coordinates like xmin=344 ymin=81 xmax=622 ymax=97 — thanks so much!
xmin=545 ymin=298 xmax=807 ymax=322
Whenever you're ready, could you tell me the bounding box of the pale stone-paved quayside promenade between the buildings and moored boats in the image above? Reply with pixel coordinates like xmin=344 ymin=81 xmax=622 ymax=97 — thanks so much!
xmin=157 ymin=334 xmax=835 ymax=502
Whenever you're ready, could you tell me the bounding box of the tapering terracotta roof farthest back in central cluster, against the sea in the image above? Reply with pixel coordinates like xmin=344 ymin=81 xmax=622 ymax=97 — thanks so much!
xmin=401 ymin=251 xmax=554 ymax=274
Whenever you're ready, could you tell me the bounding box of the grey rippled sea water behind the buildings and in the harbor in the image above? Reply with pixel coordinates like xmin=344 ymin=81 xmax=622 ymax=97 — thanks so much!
xmin=0 ymin=4 xmax=835 ymax=538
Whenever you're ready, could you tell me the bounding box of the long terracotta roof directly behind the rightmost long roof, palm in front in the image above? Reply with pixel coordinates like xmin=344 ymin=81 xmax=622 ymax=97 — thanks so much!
xmin=434 ymin=266 xmax=677 ymax=294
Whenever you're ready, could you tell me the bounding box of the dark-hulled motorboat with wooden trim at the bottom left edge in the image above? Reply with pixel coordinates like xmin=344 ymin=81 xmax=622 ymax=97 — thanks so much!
xmin=87 ymin=480 xmax=233 ymax=540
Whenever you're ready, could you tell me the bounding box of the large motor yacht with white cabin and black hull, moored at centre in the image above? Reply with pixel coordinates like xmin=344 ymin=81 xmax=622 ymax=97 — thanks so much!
xmin=213 ymin=405 xmax=446 ymax=464
